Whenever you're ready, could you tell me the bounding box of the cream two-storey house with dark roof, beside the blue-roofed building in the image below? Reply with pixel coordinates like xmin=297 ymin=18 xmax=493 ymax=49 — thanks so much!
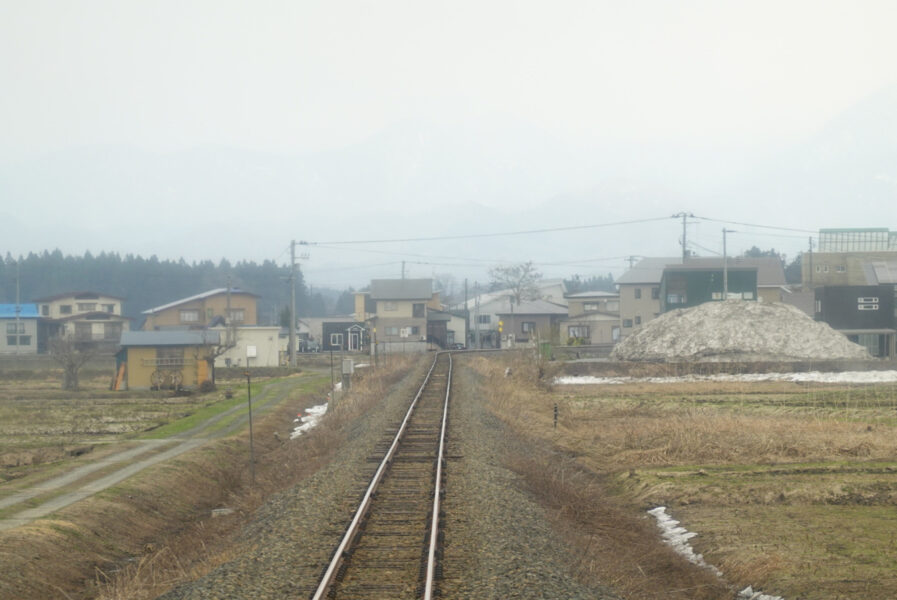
xmin=35 ymin=292 xmax=131 ymax=344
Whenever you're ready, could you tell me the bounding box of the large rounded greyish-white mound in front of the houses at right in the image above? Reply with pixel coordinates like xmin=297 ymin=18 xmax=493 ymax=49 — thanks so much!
xmin=611 ymin=300 xmax=871 ymax=362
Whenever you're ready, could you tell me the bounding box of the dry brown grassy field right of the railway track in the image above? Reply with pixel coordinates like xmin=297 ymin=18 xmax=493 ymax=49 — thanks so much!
xmin=471 ymin=357 xmax=897 ymax=600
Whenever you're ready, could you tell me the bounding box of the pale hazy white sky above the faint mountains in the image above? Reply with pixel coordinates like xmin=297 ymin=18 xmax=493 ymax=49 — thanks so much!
xmin=0 ymin=0 xmax=897 ymax=286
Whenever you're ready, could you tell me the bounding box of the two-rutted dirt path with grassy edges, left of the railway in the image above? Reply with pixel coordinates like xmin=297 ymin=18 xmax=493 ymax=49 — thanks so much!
xmin=0 ymin=378 xmax=298 ymax=531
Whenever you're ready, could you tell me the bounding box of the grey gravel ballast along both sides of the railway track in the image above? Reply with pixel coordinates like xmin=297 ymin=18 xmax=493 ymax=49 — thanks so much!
xmin=156 ymin=358 xmax=616 ymax=600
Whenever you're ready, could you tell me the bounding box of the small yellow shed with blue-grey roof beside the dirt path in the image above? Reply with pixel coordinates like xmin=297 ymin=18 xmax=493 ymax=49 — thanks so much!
xmin=115 ymin=330 xmax=221 ymax=390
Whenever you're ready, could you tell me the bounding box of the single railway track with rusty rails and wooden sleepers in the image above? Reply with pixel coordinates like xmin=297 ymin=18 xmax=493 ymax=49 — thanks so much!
xmin=311 ymin=353 xmax=452 ymax=600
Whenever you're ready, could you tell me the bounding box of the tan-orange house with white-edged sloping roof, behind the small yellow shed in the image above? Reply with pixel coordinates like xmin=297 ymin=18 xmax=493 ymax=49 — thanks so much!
xmin=143 ymin=288 xmax=258 ymax=331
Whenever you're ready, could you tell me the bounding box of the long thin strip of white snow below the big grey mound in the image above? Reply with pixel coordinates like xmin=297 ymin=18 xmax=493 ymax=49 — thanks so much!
xmin=554 ymin=371 xmax=897 ymax=385
